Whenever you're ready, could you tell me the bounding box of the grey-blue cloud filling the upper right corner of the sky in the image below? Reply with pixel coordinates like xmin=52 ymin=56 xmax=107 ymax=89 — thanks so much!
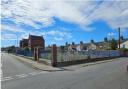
xmin=89 ymin=1 xmax=128 ymax=29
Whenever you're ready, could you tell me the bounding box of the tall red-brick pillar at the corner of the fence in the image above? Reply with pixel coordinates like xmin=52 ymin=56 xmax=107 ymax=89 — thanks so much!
xmin=51 ymin=44 xmax=57 ymax=67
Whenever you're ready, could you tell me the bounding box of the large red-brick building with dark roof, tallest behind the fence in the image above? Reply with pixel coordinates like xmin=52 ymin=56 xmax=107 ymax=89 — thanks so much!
xmin=28 ymin=35 xmax=45 ymax=50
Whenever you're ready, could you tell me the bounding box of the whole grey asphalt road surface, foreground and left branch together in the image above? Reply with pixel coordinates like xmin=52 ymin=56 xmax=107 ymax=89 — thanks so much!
xmin=2 ymin=54 xmax=128 ymax=89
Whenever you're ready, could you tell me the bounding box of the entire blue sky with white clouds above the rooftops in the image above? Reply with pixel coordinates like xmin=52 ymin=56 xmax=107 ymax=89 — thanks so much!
xmin=1 ymin=0 xmax=128 ymax=47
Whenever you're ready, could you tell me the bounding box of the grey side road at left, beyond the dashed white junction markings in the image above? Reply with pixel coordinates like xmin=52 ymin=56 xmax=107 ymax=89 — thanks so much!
xmin=1 ymin=53 xmax=38 ymax=77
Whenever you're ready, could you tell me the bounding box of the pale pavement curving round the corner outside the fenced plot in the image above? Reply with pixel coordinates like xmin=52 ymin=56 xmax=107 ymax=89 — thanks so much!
xmin=10 ymin=54 xmax=124 ymax=72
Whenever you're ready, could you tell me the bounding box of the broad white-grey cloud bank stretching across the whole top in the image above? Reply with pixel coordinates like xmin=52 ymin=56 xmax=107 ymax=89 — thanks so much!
xmin=1 ymin=0 xmax=128 ymax=31
